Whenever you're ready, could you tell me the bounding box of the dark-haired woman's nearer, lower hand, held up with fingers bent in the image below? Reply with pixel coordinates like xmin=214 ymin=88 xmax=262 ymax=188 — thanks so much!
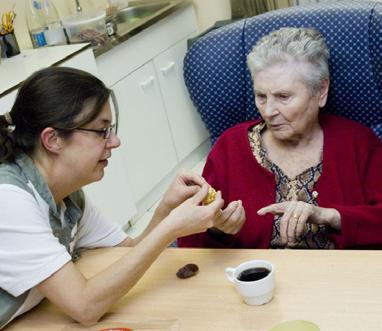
xmin=164 ymin=183 xmax=224 ymax=239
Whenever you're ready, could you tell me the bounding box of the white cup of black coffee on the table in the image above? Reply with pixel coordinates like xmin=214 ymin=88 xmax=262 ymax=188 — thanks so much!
xmin=225 ymin=260 xmax=275 ymax=306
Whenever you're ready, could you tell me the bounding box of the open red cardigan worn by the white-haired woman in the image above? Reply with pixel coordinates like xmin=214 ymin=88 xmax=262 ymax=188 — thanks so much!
xmin=178 ymin=114 xmax=382 ymax=248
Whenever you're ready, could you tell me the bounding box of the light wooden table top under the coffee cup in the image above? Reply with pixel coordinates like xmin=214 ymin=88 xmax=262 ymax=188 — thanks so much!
xmin=5 ymin=248 xmax=382 ymax=331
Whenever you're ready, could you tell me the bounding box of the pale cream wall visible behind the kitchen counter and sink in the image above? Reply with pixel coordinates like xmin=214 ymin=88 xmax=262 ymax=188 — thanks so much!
xmin=0 ymin=0 xmax=231 ymax=49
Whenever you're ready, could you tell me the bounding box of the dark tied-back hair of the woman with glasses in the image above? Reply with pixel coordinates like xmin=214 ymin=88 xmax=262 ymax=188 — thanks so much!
xmin=0 ymin=67 xmax=111 ymax=162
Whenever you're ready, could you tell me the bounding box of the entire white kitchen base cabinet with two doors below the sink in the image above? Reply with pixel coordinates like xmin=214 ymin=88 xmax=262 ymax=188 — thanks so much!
xmin=96 ymin=5 xmax=209 ymax=222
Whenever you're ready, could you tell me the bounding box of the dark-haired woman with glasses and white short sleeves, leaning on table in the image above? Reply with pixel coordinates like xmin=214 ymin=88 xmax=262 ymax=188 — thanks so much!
xmin=0 ymin=67 xmax=223 ymax=329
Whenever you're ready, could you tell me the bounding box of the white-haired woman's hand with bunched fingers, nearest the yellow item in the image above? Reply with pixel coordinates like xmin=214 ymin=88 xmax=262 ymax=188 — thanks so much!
xmin=215 ymin=200 xmax=246 ymax=234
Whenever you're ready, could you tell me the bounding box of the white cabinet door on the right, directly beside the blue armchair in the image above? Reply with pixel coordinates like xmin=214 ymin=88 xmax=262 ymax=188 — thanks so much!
xmin=154 ymin=39 xmax=208 ymax=161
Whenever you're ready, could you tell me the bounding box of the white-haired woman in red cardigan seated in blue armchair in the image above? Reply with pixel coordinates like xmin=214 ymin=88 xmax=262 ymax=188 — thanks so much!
xmin=178 ymin=28 xmax=382 ymax=249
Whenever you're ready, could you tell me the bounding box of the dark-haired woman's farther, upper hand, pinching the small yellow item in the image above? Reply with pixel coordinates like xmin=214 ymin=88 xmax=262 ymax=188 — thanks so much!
xmin=161 ymin=170 xmax=206 ymax=213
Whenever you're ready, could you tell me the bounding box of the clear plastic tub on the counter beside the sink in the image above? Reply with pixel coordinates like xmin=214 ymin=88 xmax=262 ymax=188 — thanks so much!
xmin=62 ymin=10 xmax=108 ymax=49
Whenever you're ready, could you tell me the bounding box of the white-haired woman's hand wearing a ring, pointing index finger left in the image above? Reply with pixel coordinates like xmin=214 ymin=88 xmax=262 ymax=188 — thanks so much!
xmin=257 ymin=201 xmax=341 ymax=244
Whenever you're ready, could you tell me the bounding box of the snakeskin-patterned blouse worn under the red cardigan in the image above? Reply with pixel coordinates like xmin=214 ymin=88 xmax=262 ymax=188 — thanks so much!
xmin=248 ymin=123 xmax=334 ymax=249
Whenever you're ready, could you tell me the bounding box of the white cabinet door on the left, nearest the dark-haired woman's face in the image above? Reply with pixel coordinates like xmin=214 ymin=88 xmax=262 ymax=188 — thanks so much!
xmin=113 ymin=61 xmax=177 ymax=201
